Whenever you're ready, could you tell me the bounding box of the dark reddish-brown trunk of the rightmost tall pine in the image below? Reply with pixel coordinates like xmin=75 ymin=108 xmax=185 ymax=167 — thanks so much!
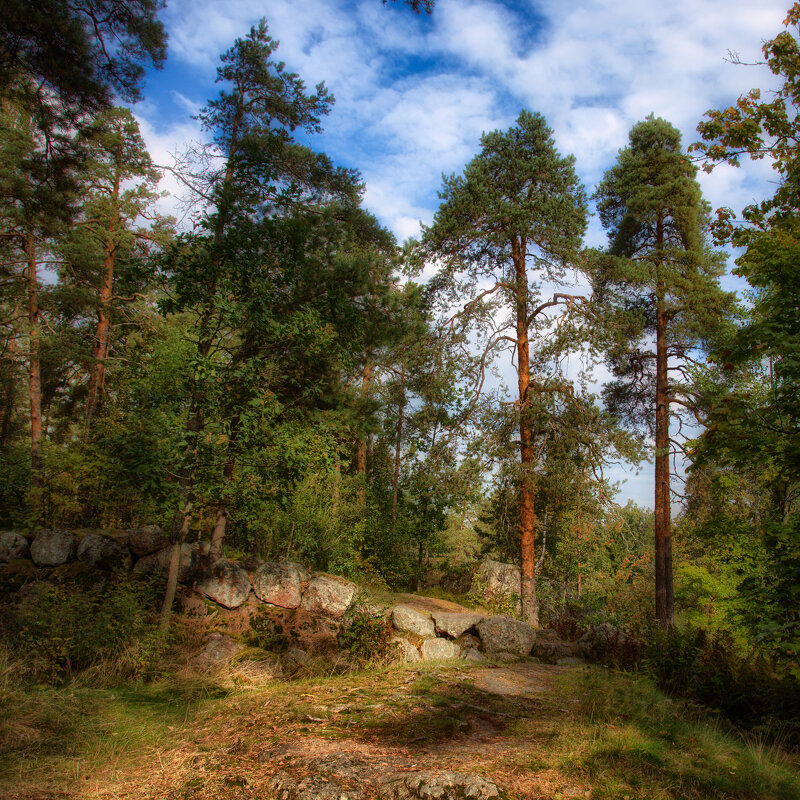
xmin=655 ymin=287 xmax=674 ymax=628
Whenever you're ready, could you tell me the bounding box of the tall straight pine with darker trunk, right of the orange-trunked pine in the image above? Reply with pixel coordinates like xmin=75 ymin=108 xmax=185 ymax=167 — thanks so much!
xmin=592 ymin=115 xmax=732 ymax=626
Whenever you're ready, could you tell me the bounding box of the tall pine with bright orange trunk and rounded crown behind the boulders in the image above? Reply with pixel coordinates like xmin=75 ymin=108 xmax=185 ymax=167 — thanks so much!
xmin=423 ymin=111 xmax=586 ymax=624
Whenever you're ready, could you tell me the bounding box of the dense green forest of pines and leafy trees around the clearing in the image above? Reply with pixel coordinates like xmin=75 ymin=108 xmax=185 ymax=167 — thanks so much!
xmin=0 ymin=0 xmax=800 ymax=798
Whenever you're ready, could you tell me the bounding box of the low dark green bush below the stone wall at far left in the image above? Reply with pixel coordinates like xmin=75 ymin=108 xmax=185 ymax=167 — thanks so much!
xmin=0 ymin=576 xmax=165 ymax=684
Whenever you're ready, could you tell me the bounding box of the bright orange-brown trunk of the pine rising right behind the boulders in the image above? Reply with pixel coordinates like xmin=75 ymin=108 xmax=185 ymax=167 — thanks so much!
xmin=513 ymin=238 xmax=539 ymax=627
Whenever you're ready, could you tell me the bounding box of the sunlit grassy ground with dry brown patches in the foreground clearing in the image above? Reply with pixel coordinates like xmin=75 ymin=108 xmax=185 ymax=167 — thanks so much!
xmin=0 ymin=662 xmax=800 ymax=800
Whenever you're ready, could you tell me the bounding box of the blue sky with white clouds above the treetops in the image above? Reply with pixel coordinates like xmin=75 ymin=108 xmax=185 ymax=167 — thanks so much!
xmin=133 ymin=0 xmax=788 ymax=506
